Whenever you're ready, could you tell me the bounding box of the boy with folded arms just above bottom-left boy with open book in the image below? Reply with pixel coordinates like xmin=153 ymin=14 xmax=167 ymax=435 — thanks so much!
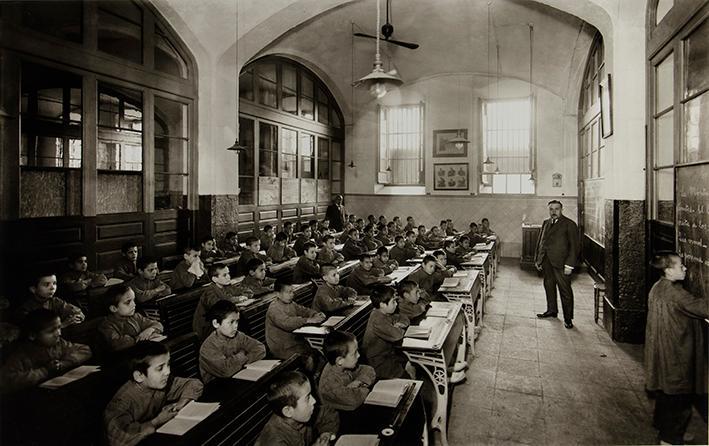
xmin=98 ymin=284 xmax=163 ymax=351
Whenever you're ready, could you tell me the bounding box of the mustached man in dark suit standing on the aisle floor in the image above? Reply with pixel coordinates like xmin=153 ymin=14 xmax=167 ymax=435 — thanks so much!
xmin=534 ymin=200 xmax=579 ymax=328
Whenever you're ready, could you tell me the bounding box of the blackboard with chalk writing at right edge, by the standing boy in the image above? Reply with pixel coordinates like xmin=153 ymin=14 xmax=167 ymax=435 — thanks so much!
xmin=675 ymin=164 xmax=709 ymax=298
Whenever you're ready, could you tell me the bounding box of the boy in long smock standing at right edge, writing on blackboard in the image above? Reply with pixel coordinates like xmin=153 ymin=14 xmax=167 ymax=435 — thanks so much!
xmin=645 ymin=253 xmax=709 ymax=444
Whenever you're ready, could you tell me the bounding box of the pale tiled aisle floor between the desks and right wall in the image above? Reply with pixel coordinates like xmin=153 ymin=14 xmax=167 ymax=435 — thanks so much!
xmin=448 ymin=259 xmax=707 ymax=446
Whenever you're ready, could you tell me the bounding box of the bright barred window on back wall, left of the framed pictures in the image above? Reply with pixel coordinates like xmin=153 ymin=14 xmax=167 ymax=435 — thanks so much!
xmin=379 ymin=104 xmax=424 ymax=186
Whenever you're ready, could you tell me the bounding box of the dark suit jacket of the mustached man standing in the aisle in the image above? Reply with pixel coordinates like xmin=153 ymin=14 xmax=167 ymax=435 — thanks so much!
xmin=535 ymin=215 xmax=579 ymax=268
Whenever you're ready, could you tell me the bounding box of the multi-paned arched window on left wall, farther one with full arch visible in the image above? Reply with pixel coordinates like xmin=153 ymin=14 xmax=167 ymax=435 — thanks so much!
xmin=239 ymin=56 xmax=344 ymax=232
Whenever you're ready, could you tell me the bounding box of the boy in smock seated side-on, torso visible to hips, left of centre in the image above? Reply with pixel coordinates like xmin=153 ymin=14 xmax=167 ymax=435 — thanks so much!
xmin=266 ymin=281 xmax=325 ymax=362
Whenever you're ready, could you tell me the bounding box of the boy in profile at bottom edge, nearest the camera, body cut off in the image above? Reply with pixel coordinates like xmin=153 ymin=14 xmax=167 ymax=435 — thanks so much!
xmin=255 ymin=371 xmax=333 ymax=446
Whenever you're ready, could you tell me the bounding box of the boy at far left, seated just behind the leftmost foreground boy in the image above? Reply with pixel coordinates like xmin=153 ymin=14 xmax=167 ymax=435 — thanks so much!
xmin=15 ymin=272 xmax=84 ymax=328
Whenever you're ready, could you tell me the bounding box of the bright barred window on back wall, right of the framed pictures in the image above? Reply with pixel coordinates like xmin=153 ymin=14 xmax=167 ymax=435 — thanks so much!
xmin=480 ymin=97 xmax=534 ymax=194
